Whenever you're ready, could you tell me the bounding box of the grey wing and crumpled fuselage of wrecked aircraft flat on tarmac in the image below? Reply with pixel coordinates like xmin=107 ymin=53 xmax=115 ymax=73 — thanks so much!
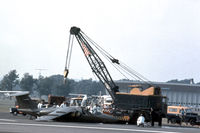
xmin=36 ymin=107 xmax=121 ymax=123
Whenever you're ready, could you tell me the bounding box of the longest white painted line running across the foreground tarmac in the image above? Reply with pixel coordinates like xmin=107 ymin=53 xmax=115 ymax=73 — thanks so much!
xmin=0 ymin=122 xmax=180 ymax=133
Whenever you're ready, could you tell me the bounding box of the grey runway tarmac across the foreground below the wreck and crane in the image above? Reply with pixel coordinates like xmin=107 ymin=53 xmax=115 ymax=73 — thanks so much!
xmin=0 ymin=113 xmax=200 ymax=133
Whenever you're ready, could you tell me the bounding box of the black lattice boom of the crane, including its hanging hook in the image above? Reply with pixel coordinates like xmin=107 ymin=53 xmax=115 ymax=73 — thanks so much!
xmin=64 ymin=27 xmax=119 ymax=100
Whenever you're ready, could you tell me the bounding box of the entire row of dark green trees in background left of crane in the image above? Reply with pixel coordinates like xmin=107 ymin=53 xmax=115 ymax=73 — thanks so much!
xmin=0 ymin=70 xmax=105 ymax=97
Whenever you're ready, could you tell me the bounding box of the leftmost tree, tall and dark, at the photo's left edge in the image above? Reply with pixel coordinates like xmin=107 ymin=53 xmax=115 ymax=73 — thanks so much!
xmin=0 ymin=70 xmax=19 ymax=91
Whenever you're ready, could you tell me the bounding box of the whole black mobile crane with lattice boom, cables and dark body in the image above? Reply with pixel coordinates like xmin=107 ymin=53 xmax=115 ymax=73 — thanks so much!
xmin=64 ymin=27 xmax=167 ymax=126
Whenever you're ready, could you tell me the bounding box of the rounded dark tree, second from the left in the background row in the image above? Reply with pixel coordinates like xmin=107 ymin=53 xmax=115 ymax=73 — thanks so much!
xmin=20 ymin=73 xmax=36 ymax=93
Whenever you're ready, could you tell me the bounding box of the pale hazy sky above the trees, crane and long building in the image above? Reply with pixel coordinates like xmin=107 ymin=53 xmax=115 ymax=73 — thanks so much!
xmin=0 ymin=0 xmax=200 ymax=82
